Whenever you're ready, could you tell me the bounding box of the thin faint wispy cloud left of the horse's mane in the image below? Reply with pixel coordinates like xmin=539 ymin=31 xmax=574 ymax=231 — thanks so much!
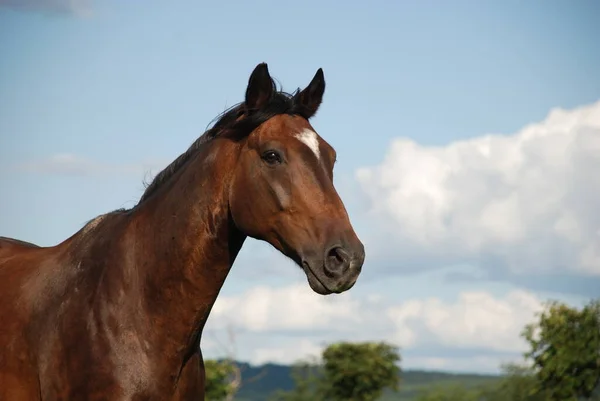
xmin=17 ymin=153 xmax=166 ymax=176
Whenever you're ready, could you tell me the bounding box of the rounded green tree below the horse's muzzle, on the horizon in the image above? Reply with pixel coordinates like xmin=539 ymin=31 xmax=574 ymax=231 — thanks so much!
xmin=321 ymin=342 xmax=400 ymax=401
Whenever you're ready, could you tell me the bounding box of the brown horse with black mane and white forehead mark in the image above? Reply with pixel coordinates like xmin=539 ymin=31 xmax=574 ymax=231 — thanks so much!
xmin=0 ymin=63 xmax=365 ymax=401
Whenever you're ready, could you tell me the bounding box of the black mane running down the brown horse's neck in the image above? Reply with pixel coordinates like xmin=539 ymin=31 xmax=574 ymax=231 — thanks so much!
xmin=138 ymin=82 xmax=310 ymax=204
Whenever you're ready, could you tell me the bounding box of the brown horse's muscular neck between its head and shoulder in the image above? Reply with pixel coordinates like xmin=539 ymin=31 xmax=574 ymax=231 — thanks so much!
xmin=126 ymin=142 xmax=245 ymax=358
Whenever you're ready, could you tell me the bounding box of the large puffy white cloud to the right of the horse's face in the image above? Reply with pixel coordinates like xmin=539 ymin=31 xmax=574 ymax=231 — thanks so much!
xmin=357 ymin=101 xmax=600 ymax=276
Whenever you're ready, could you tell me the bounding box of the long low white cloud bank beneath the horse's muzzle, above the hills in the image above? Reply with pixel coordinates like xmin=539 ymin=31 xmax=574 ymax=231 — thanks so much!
xmin=202 ymin=283 xmax=542 ymax=372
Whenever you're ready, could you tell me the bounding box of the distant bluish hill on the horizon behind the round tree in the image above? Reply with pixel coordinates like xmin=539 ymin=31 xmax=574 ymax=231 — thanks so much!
xmin=227 ymin=362 xmax=499 ymax=401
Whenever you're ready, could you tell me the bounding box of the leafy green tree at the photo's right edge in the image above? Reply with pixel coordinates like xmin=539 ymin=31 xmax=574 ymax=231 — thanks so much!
xmin=522 ymin=301 xmax=600 ymax=401
